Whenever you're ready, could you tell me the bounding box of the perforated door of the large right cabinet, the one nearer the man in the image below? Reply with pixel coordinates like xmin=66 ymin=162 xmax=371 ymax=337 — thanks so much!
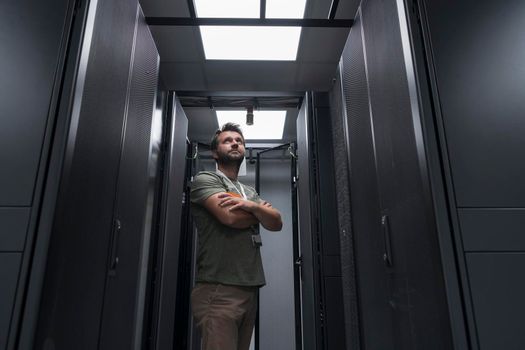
xmin=338 ymin=13 xmax=392 ymax=349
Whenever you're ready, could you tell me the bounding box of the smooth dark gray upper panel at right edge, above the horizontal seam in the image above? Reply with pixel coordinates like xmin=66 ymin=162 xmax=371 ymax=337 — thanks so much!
xmin=425 ymin=0 xmax=525 ymax=207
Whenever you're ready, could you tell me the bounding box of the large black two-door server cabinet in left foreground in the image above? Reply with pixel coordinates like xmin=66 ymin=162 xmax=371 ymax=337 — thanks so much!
xmin=34 ymin=0 xmax=159 ymax=349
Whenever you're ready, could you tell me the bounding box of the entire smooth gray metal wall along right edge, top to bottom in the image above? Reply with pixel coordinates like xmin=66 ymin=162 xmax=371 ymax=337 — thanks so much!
xmin=422 ymin=0 xmax=525 ymax=349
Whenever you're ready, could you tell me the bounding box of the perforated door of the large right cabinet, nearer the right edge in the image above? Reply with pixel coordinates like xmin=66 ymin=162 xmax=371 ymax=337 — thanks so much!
xmin=362 ymin=0 xmax=452 ymax=350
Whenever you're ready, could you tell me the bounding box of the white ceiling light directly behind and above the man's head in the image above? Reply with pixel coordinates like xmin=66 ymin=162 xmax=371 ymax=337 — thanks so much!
xmin=217 ymin=110 xmax=286 ymax=140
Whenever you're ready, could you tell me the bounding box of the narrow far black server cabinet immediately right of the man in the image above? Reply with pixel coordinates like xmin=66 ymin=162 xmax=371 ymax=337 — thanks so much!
xmin=297 ymin=92 xmax=351 ymax=349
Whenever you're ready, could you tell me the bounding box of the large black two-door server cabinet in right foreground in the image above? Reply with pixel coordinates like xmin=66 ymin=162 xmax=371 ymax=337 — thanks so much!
xmin=334 ymin=0 xmax=454 ymax=350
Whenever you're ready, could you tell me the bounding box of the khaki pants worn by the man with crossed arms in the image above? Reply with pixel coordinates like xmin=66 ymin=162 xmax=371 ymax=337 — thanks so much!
xmin=191 ymin=283 xmax=258 ymax=350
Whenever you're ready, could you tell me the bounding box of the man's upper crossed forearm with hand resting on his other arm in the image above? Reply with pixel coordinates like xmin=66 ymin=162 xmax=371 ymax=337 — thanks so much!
xmin=217 ymin=193 xmax=283 ymax=231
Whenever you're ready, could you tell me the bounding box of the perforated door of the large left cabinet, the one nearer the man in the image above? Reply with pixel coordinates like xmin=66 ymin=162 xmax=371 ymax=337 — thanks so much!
xmin=100 ymin=9 xmax=159 ymax=349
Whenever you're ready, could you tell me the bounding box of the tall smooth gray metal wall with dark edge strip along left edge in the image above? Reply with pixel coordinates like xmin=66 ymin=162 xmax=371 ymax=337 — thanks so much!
xmin=0 ymin=0 xmax=72 ymax=350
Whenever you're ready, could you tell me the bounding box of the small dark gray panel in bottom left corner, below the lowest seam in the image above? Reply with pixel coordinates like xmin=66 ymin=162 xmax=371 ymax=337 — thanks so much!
xmin=0 ymin=253 xmax=22 ymax=349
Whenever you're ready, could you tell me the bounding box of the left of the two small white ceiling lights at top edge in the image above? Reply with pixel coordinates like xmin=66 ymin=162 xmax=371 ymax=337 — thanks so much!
xmin=195 ymin=0 xmax=261 ymax=18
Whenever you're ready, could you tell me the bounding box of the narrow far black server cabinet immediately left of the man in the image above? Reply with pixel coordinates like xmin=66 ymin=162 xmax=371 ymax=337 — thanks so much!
xmin=150 ymin=92 xmax=189 ymax=349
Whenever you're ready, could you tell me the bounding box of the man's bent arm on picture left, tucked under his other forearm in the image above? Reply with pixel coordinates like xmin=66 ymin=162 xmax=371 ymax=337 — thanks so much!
xmin=203 ymin=192 xmax=259 ymax=229
